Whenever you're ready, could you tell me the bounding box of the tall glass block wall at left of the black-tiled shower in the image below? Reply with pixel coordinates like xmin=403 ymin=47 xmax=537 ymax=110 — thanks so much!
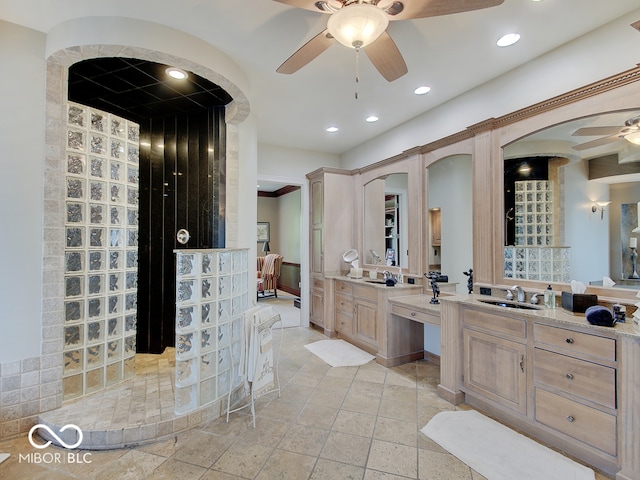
xmin=62 ymin=102 xmax=139 ymax=400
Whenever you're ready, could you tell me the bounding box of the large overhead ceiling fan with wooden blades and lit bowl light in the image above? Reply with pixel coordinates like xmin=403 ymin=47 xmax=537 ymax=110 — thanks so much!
xmin=274 ymin=0 xmax=504 ymax=82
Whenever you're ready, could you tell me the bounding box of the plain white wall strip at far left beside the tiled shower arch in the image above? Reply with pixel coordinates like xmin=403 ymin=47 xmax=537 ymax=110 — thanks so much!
xmin=0 ymin=21 xmax=45 ymax=362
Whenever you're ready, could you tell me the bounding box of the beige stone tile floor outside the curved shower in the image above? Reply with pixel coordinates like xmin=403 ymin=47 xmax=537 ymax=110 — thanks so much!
xmin=0 ymin=328 xmax=609 ymax=480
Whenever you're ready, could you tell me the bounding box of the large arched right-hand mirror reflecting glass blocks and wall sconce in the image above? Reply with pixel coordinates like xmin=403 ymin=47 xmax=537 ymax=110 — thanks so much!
xmin=501 ymin=110 xmax=640 ymax=289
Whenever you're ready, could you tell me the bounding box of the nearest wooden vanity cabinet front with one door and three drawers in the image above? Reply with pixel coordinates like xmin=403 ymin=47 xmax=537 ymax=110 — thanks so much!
xmin=452 ymin=306 xmax=624 ymax=479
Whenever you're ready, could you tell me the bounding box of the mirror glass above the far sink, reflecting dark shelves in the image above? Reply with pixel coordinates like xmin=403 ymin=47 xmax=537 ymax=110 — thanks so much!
xmin=362 ymin=173 xmax=409 ymax=268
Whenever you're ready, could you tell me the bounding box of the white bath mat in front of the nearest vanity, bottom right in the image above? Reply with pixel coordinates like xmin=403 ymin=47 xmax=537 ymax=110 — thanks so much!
xmin=420 ymin=410 xmax=595 ymax=480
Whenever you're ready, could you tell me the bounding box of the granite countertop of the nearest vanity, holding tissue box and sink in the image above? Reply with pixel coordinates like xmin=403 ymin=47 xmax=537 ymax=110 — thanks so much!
xmin=440 ymin=294 xmax=640 ymax=339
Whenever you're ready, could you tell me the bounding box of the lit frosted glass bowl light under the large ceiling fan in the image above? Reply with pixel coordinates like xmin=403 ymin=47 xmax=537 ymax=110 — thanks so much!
xmin=327 ymin=3 xmax=389 ymax=48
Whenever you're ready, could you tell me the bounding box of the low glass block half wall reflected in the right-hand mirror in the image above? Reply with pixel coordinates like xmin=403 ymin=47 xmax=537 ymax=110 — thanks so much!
xmin=504 ymin=246 xmax=571 ymax=283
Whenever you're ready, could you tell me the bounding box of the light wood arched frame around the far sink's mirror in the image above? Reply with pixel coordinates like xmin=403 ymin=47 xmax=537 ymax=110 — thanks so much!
xmin=354 ymin=154 xmax=423 ymax=275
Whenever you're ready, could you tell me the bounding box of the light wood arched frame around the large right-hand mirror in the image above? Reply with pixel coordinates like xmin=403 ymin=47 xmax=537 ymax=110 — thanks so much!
xmin=490 ymin=69 xmax=640 ymax=301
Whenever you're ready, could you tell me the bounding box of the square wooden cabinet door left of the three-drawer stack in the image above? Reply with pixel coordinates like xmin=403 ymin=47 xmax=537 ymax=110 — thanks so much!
xmin=463 ymin=328 xmax=527 ymax=414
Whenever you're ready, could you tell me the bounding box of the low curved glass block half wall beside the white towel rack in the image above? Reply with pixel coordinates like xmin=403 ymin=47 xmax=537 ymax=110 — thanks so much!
xmin=175 ymin=249 xmax=250 ymax=415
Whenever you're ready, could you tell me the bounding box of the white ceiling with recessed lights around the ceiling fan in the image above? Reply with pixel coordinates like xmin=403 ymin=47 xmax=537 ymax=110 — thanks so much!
xmin=0 ymin=0 xmax=640 ymax=154
